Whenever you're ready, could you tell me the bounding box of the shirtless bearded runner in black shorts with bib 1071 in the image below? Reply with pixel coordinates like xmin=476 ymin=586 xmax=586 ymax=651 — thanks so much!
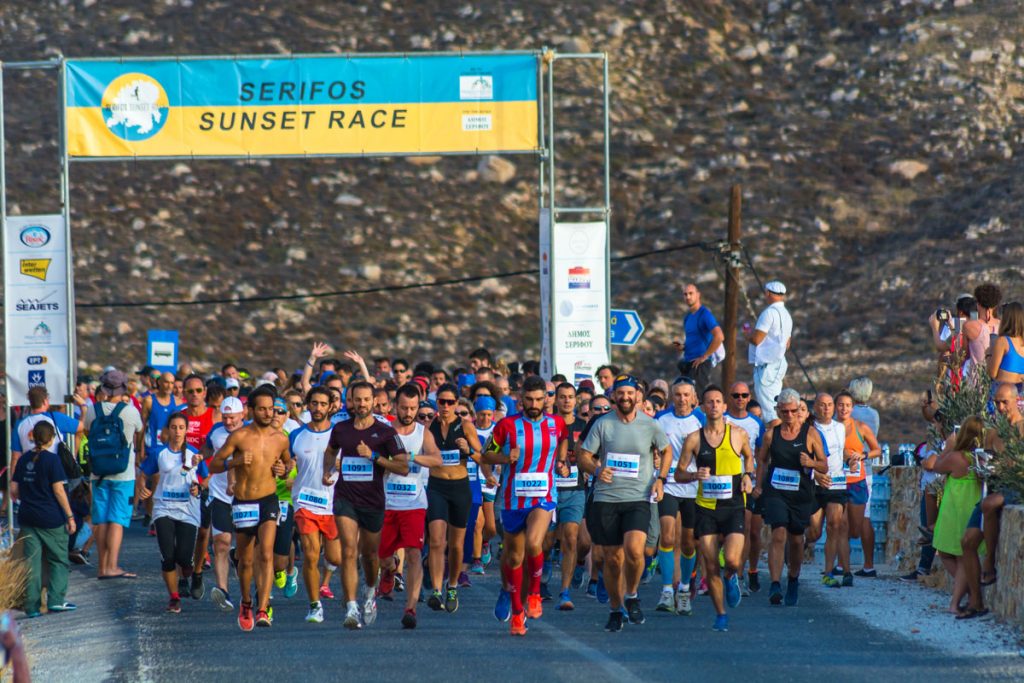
xmin=210 ymin=387 xmax=292 ymax=631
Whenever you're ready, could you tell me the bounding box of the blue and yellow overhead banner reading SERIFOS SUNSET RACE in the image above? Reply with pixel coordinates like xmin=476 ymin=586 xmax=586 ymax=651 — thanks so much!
xmin=66 ymin=54 xmax=539 ymax=158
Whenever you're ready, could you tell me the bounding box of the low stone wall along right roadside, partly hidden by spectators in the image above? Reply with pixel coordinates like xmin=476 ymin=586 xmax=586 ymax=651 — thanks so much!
xmin=886 ymin=467 xmax=1024 ymax=624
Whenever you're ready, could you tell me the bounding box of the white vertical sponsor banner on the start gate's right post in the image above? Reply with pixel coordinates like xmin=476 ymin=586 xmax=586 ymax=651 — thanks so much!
xmin=551 ymin=222 xmax=608 ymax=384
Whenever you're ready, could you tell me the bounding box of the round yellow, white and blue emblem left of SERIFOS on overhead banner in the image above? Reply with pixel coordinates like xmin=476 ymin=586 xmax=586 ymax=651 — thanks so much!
xmin=100 ymin=74 xmax=170 ymax=142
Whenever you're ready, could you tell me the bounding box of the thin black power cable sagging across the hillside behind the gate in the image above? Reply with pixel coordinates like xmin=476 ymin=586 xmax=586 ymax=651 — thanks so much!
xmin=76 ymin=237 xmax=718 ymax=308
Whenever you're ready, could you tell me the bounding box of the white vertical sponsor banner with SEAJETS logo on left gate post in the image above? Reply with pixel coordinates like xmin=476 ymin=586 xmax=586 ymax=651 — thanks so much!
xmin=4 ymin=216 xmax=69 ymax=405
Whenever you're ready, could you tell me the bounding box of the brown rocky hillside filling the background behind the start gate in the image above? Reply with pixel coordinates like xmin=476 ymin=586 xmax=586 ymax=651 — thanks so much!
xmin=0 ymin=0 xmax=1024 ymax=438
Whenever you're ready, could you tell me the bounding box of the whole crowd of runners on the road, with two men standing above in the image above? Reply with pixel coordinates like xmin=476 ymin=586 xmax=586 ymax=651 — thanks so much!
xmin=6 ymin=282 xmax=929 ymax=636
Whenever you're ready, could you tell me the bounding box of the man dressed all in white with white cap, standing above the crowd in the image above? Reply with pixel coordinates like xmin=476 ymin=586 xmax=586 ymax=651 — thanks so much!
xmin=746 ymin=280 xmax=793 ymax=424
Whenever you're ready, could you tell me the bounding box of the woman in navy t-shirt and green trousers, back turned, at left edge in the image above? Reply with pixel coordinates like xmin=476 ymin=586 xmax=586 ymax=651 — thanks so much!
xmin=10 ymin=420 xmax=75 ymax=617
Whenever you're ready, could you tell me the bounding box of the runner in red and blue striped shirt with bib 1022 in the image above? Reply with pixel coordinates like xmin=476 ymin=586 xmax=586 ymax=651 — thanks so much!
xmin=484 ymin=377 xmax=568 ymax=636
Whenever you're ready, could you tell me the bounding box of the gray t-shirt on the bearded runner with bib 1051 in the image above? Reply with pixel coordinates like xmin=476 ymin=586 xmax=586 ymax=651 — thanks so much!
xmin=583 ymin=413 xmax=669 ymax=503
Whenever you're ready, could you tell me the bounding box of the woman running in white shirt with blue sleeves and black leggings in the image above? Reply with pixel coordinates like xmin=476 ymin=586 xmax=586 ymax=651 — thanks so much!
xmin=139 ymin=413 xmax=210 ymax=614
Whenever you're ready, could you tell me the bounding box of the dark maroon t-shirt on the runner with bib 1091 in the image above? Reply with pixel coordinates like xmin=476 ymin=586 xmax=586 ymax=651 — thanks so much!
xmin=328 ymin=418 xmax=406 ymax=510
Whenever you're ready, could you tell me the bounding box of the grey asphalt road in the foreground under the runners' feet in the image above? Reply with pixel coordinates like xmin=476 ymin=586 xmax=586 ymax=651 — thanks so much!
xmin=14 ymin=527 xmax=1024 ymax=683
